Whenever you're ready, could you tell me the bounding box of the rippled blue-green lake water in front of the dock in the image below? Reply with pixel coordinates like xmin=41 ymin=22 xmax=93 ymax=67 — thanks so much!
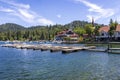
xmin=0 ymin=42 xmax=120 ymax=80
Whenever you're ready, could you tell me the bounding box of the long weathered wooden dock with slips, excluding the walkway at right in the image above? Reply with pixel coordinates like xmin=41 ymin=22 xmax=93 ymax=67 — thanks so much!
xmin=2 ymin=44 xmax=96 ymax=53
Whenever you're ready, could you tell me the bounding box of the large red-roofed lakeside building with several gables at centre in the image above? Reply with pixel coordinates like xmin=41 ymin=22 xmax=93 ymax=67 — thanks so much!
xmin=55 ymin=29 xmax=79 ymax=41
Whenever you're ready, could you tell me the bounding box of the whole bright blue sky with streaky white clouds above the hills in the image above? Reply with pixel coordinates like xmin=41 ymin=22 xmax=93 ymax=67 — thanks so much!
xmin=0 ymin=0 xmax=120 ymax=27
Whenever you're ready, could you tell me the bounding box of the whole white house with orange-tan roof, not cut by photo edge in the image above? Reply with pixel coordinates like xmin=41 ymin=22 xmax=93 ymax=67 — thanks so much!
xmin=96 ymin=26 xmax=110 ymax=41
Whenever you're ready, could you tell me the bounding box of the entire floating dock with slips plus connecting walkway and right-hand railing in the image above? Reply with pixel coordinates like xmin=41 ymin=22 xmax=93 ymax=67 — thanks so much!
xmin=1 ymin=43 xmax=120 ymax=53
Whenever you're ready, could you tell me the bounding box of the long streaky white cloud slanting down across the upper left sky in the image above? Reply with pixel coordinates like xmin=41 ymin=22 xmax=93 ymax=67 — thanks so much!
xmin=0 ymin=0 xmax=54 ymax=25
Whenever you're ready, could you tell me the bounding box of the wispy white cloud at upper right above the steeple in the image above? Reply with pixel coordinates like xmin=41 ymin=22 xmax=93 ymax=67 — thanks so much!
xmin=75 ymin=0 xmax=115 ymax=20
